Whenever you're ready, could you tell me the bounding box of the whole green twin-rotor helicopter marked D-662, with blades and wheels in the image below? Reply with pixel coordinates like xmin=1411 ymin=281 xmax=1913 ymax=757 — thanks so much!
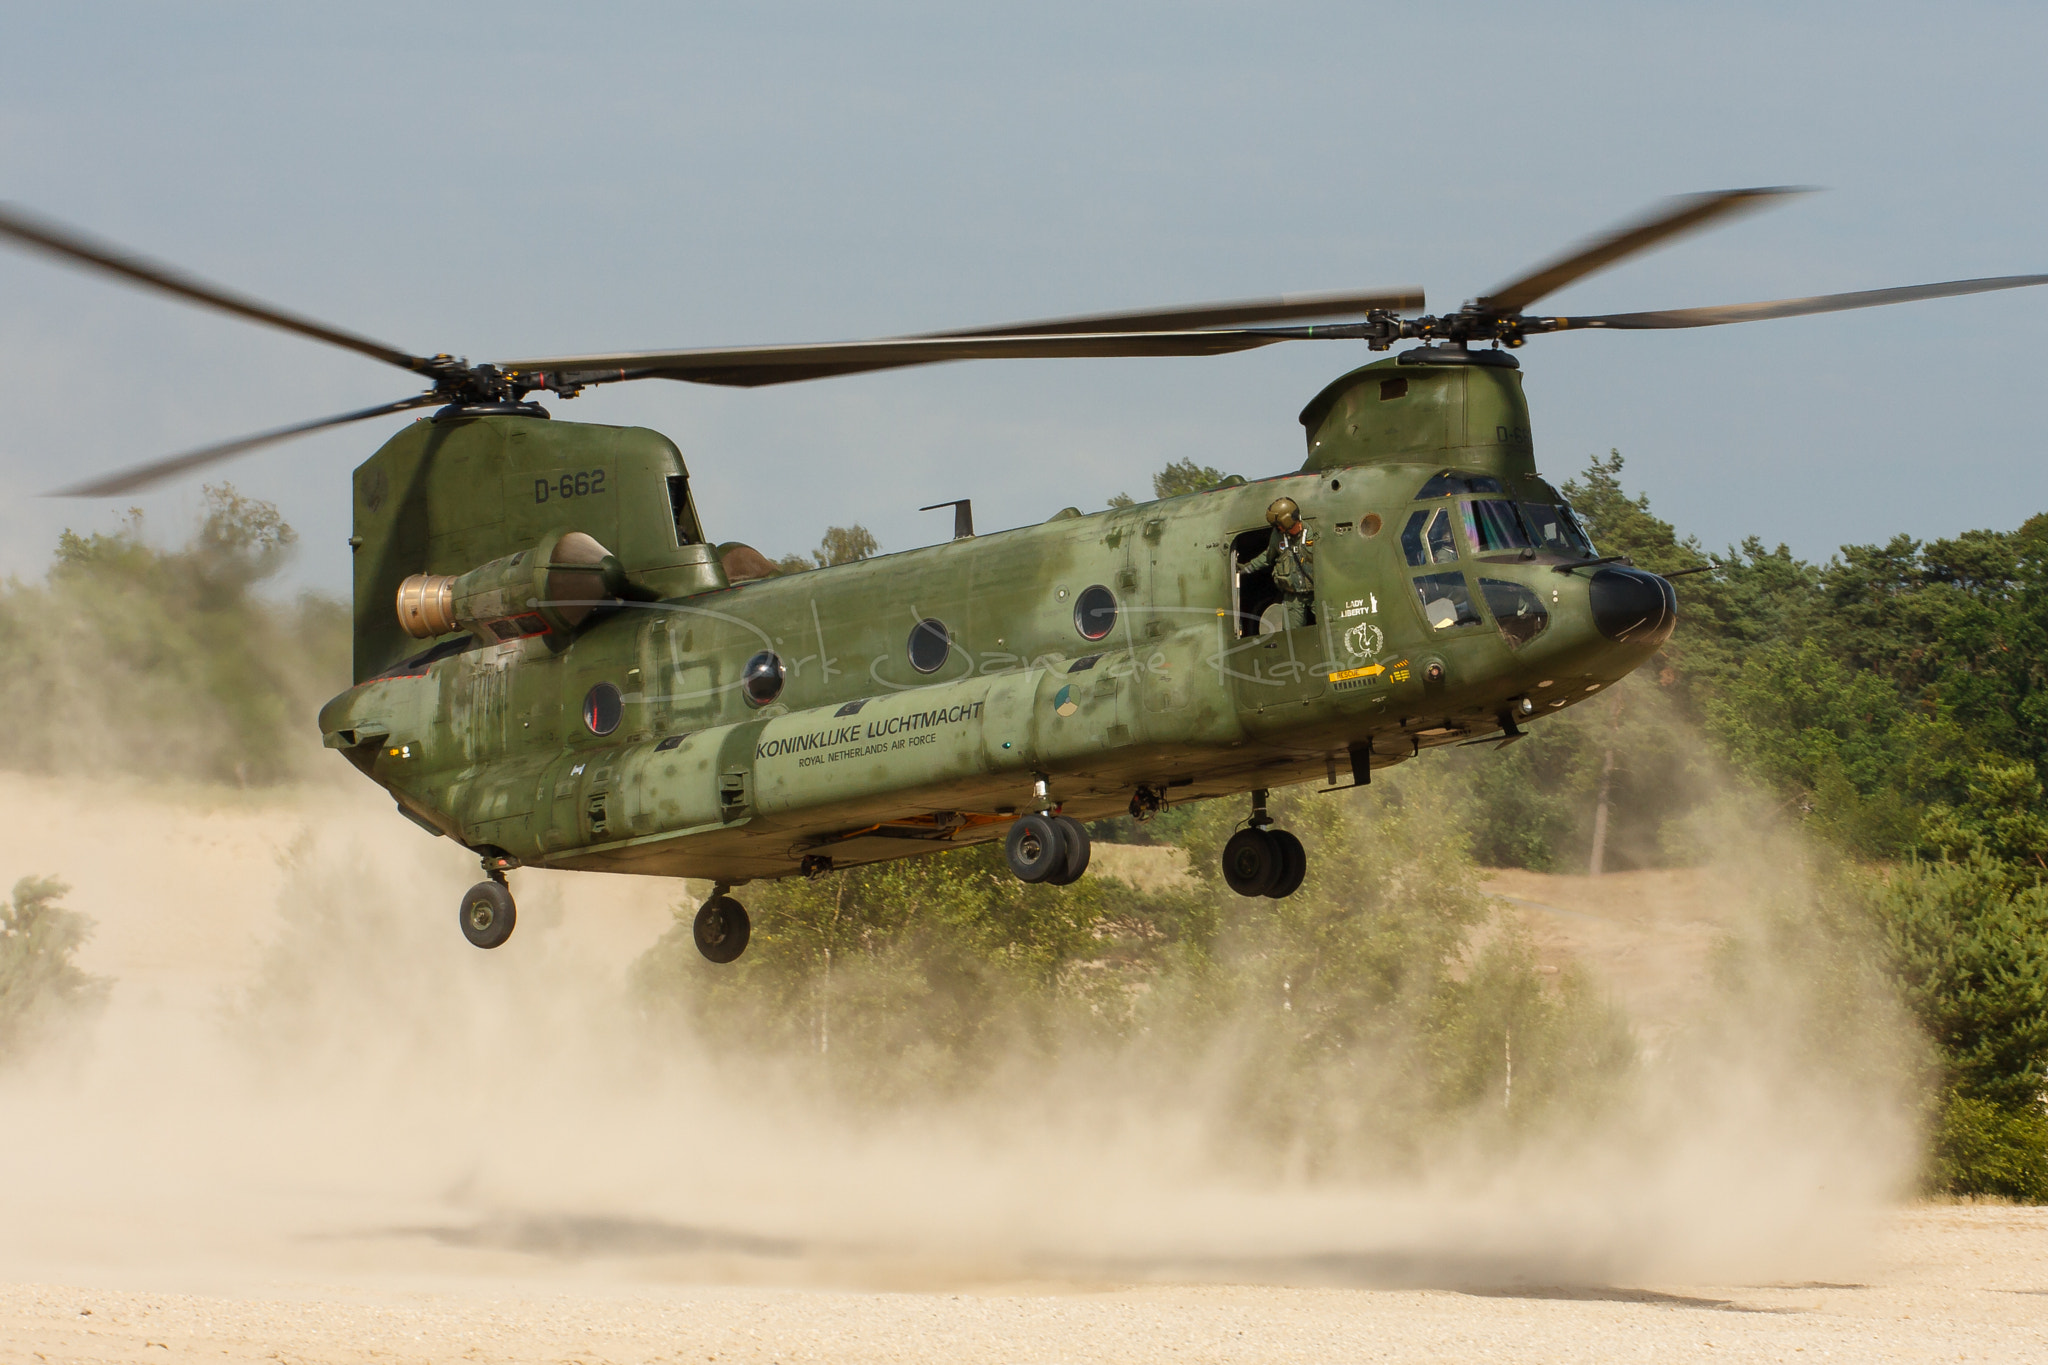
xmin=0 ymin=188 xmax=2048 ymax=962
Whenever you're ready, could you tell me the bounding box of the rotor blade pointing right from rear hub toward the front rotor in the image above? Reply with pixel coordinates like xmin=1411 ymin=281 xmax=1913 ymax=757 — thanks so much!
xmin=498 ymin=327 xmax=1356 ymax=389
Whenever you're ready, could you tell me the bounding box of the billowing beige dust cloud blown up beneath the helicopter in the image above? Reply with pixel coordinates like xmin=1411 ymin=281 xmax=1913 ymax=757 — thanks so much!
xmin=0 ymin=776 xmax=1917 ymax=1289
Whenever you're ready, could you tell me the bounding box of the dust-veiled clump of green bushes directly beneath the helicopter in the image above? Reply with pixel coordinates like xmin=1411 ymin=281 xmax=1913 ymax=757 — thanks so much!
xmin=635 ymin=782 xmax=1634 ymax=1173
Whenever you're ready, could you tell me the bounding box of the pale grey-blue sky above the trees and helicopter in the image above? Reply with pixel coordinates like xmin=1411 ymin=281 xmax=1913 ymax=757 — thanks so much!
xmin=0 ymin=2 xmax=2048 ymax=589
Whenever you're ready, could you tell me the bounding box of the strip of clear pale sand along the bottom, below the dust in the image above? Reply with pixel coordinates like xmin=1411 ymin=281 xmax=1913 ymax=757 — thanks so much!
xmin=0 ymin=1207 xmax=2048 ymax=1363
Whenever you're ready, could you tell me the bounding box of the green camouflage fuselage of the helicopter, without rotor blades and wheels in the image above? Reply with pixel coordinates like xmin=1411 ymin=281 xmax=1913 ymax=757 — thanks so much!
xmin=319 ymin=349 xmax=1669 ymax=882
